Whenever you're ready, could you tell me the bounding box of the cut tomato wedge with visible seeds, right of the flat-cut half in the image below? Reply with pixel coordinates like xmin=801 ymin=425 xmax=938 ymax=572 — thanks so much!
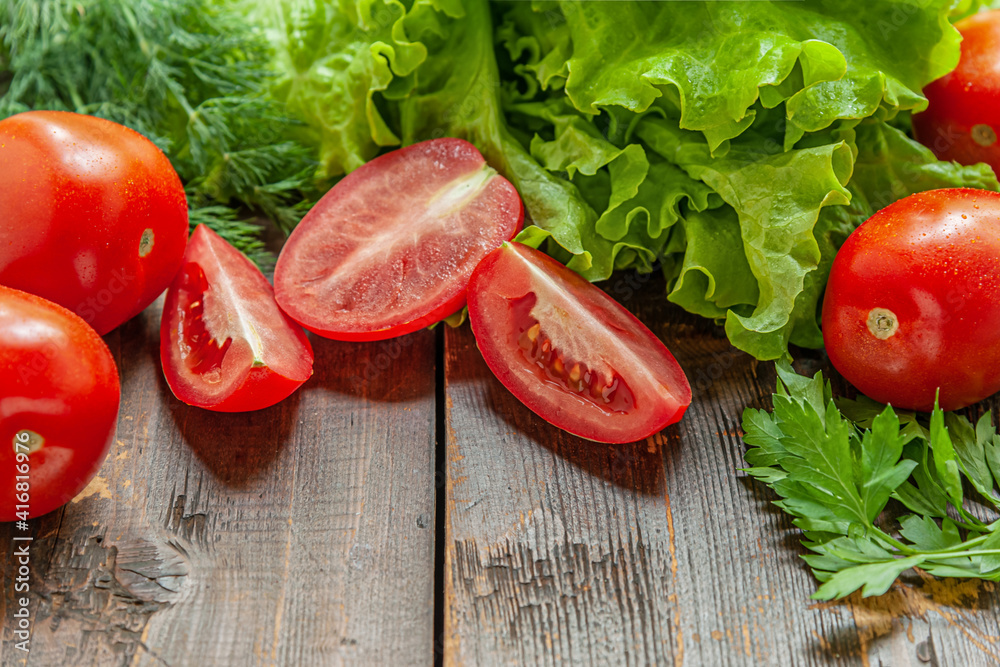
xmin=469 ymin=243 xmax=691 ymax=443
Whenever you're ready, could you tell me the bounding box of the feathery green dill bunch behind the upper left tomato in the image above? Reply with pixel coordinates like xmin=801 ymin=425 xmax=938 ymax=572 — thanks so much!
xmin=0 ymin=0 xmax=319 ymax=264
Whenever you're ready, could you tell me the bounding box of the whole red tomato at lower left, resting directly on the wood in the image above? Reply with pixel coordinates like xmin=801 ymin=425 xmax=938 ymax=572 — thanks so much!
xmin=0 ymin=286 xmax=121 ymax=521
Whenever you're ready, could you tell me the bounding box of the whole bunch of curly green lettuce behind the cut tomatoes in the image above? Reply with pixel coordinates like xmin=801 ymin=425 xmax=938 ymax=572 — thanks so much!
xmin=263 ymin=0 xmax=1000 ymax=359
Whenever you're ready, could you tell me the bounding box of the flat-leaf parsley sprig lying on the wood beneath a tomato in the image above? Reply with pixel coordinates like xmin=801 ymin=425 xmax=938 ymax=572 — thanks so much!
xmin=743 ymin=362 xmax=1000 ymax=600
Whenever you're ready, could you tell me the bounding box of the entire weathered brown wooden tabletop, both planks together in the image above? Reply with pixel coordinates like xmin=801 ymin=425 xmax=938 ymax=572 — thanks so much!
xmin=0 ymin=276 xmax=1000 ymax=667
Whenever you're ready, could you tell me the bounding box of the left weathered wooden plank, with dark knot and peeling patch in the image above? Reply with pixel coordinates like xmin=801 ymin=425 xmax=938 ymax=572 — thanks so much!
xmin=0 ymin=304 xmax=435 ymax=667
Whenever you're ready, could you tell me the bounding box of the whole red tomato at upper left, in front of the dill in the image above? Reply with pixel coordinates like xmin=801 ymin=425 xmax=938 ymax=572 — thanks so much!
xmin=0 ymin=111 xmax=188 ymax=334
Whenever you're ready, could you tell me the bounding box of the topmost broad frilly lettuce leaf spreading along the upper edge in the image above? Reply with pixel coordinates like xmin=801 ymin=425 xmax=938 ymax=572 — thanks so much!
xmin=507 ymin=0 xmax=959 ymax=144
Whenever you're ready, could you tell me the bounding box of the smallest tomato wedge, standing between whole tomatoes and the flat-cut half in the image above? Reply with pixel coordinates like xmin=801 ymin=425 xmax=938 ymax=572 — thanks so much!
xmin=160 ymin=225 xmax=313 ymax=412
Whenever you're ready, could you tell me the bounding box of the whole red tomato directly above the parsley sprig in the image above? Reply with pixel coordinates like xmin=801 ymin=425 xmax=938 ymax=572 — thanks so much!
xmin=823 ymin=188 xmax=1000 ymax=411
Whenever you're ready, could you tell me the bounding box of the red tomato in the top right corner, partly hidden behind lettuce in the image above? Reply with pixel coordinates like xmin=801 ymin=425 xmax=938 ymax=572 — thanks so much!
xmin=913 ymin=10 xmax=1000 ymax=174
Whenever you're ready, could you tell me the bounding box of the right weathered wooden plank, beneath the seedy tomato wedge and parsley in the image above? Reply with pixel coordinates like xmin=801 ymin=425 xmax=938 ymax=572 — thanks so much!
xmin=445 ymin=272 xmax=1000 ymax=667
